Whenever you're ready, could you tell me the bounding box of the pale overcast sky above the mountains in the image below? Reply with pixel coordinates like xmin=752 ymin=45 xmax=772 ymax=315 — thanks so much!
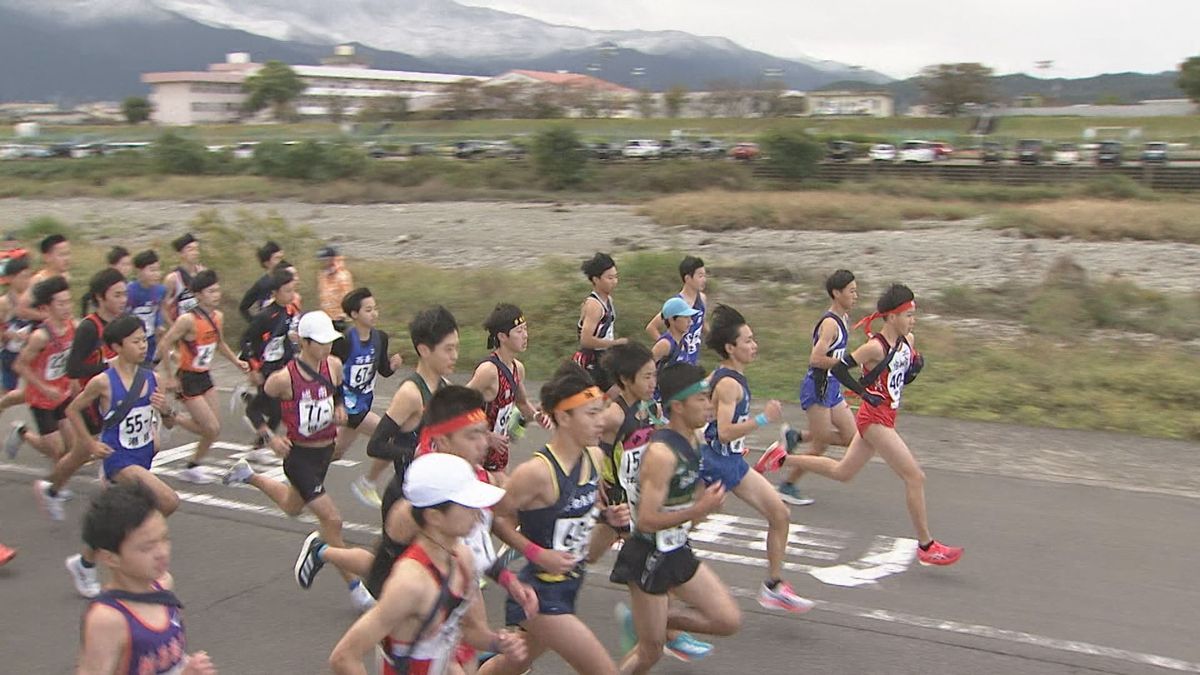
xmin=458 ymin=0 xmax=1200 ymax=78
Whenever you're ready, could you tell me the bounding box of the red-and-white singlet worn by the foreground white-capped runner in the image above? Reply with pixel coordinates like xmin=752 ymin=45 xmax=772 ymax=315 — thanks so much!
xmin=380 ymin=543 xmax=472 ymax=675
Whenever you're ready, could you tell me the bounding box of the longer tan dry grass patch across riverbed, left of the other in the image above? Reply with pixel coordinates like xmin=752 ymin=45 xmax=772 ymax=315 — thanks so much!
xmin=641 ymin=191 xmax=978 ymax=232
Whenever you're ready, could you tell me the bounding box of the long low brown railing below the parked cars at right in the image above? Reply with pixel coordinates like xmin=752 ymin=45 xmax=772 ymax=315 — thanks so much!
xmin=754 ymin=163 xmax=1200 ymax=192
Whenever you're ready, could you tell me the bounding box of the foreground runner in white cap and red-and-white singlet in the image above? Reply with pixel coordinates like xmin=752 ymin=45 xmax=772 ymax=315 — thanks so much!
xmin=329 ymin=453 xmax=527 ymax=675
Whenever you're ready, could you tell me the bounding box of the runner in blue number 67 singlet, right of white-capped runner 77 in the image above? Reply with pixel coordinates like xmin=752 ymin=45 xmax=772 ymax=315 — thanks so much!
xmin=334 ymin=288 xmax=404 ymax=508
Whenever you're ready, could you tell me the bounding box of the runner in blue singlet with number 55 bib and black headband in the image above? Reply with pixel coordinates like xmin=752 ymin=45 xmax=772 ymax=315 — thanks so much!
xmin=66 ymin=315 xmax=179 ymax=598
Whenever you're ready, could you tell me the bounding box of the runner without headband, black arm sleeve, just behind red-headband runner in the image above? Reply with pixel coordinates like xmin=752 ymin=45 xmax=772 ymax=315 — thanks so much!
xmin=367 ymin=305 xmax=458 ymax=518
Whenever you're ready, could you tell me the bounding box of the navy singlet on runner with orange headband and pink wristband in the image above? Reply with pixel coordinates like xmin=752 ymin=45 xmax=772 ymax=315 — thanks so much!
xmin=517 ymin=447 xmax=600 ymax=581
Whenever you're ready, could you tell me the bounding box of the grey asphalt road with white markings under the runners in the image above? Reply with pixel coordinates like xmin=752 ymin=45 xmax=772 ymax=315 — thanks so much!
xmin=0 ymin=365 xmax=1200 ymax=675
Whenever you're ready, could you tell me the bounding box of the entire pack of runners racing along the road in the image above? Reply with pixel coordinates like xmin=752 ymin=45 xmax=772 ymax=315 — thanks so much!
xmin=0 ymin=234 xmax=962 ymax=674
